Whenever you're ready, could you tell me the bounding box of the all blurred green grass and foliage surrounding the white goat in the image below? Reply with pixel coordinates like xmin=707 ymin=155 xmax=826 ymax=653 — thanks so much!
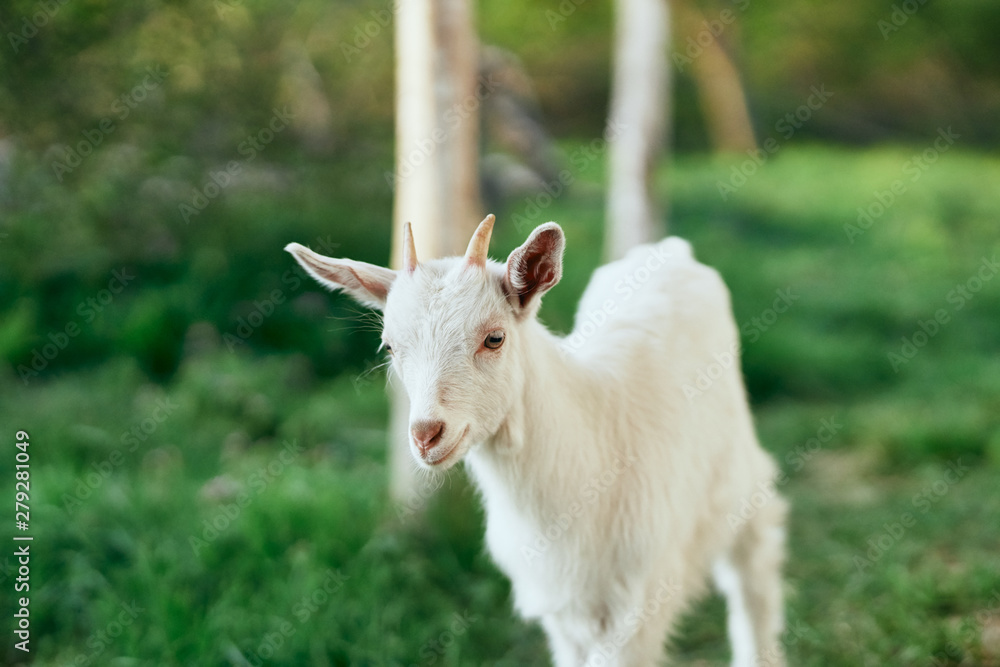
xmin=0 ymin=0 xmax=1000 ymax=666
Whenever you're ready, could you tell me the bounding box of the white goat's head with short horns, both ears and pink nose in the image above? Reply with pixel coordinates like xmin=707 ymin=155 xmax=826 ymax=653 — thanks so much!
xmin=285 ymin=215 xmax=565 ymax=470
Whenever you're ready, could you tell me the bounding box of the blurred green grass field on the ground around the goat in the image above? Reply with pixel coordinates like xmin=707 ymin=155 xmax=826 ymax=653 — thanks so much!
xmin=0 ymin=147 xmax=1000 ymax=667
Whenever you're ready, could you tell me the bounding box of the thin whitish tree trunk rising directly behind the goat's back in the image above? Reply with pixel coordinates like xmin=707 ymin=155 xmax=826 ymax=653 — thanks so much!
xmin=604 ymin=0 xmax=670 ymax=259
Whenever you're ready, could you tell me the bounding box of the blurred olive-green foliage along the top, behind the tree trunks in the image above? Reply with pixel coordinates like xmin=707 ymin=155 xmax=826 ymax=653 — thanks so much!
xmin=0 ymin=0 xmax=1000 ymax=149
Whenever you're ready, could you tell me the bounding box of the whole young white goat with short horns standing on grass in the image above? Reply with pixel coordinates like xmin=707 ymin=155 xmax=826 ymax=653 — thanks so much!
xmin=286 ymin=216 xmax=786 ymax=667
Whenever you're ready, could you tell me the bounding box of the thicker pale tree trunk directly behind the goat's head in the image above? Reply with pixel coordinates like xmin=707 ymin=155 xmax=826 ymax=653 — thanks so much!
xmin=389 ymin=0 xmax=482 ymax=510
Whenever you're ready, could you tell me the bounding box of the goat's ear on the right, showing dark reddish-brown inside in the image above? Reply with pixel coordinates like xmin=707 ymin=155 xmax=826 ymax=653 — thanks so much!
xmin=503 ymin=222 xmax=566 ymax=315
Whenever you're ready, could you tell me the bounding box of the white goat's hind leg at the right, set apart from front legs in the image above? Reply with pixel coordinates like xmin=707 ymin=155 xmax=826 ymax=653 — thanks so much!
xmin=714 ymin=496 xmax=788 ymax=667
